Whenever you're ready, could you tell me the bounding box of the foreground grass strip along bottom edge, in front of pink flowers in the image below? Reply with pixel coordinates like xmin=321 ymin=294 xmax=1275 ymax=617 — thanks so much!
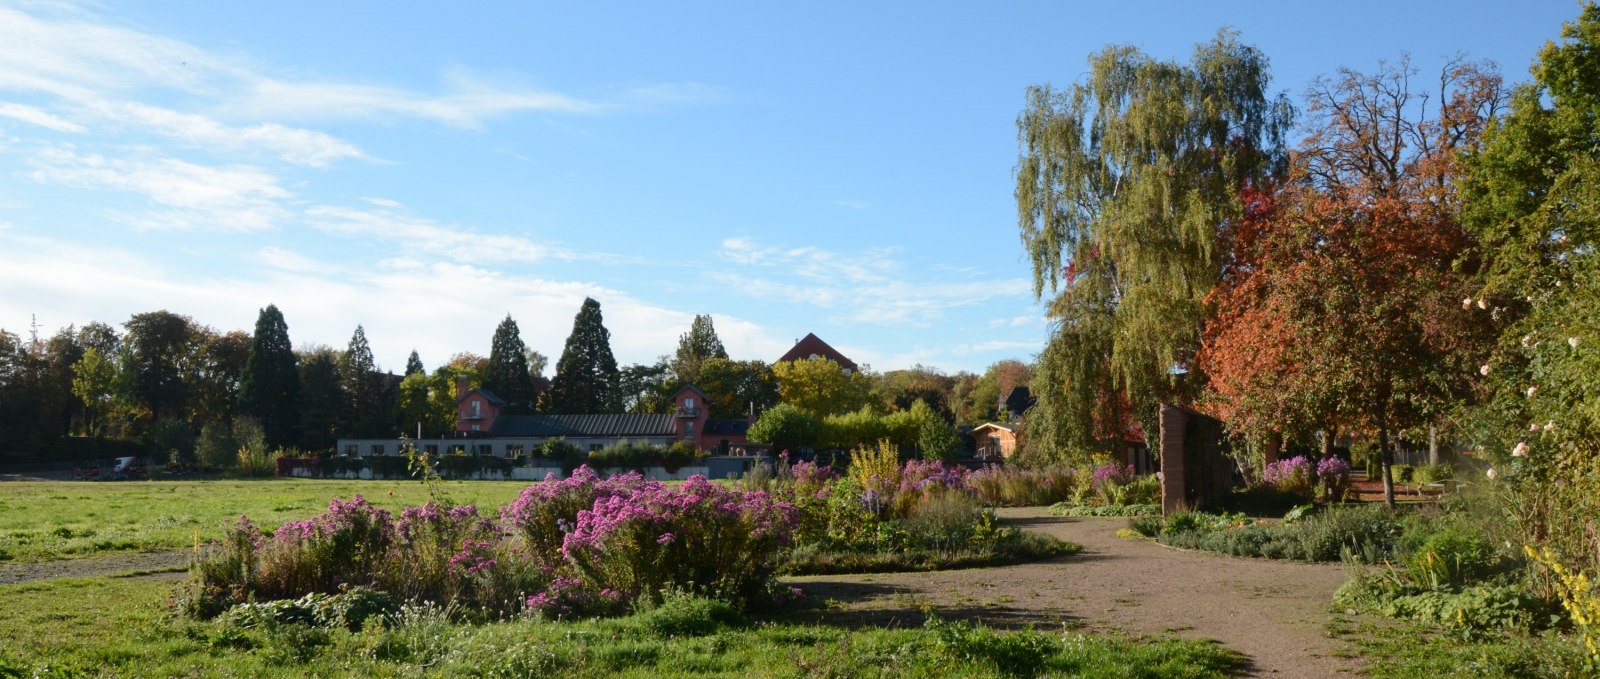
xmin=0 ymin=578 xmax=1243 ymax=677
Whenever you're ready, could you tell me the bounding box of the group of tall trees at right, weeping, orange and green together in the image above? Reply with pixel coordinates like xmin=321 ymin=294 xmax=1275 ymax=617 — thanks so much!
xmin=1016 ymin=3 xmax=1600 ymax=502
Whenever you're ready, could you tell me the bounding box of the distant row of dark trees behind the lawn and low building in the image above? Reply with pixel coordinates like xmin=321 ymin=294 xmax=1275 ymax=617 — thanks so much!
xmin=0 ymin=299 xmax=1030 ymax=463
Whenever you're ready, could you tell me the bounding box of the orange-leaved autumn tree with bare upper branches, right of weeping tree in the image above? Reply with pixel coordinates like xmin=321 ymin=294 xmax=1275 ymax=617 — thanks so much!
xmin=1197 ymin=59 xmax=1504 ymax=503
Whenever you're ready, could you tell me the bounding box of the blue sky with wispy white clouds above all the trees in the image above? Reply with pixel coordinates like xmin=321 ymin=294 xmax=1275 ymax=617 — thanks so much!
xmin=0 ymin=0 xmax=1578 ymax=372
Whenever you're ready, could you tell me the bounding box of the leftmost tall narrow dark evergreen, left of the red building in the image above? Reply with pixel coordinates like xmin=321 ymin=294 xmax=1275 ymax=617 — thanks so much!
xmin=238 ymin=304 xmax=301 ymax=448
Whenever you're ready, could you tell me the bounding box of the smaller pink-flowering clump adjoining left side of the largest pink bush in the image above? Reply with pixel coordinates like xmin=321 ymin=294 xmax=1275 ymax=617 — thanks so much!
xmin=501 ymin=464 xmax=645 ymax=572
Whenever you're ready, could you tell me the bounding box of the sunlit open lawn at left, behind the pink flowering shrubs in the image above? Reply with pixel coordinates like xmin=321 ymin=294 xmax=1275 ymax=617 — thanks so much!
xmin=0 ymin=479 xmax=528 ymax=562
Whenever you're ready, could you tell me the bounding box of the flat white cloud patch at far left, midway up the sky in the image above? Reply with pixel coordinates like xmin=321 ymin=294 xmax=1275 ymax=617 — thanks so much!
xmin=29 ymin=149 xmax=291 ymax=231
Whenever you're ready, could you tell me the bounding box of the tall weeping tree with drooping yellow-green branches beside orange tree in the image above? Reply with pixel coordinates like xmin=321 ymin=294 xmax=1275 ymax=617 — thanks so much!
xmin=1016 ymin=30 xmax=1293 ymax=456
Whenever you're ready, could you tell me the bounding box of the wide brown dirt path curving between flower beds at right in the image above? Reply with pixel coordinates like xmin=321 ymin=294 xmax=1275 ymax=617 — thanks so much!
xmin=795 ymin=508 xmax=1358 ymax=677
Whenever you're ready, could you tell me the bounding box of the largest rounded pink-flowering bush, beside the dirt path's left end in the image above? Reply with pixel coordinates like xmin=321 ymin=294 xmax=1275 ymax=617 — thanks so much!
xmin=562 ymin=476 xmax=795 ymax=601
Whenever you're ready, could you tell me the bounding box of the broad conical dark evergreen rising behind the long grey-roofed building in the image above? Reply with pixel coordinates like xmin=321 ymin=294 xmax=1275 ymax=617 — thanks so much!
xmin=550 ymin=298 xmax=622 ymax=413
